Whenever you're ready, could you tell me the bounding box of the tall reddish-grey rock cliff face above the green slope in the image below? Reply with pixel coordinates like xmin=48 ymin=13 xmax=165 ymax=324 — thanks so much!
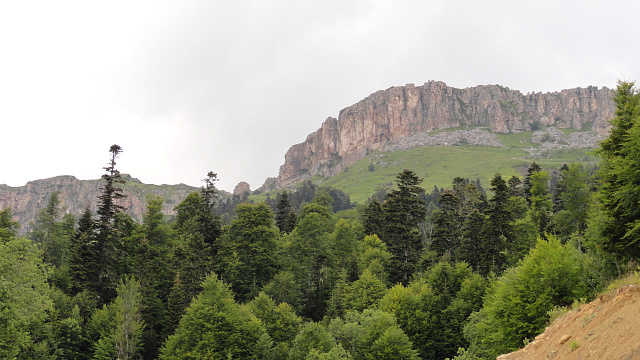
xmin=276 ymin=81 xmax=615 ymax=188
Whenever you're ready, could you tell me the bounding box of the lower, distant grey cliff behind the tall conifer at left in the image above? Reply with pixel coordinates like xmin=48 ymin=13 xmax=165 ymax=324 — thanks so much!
xmin=0 ymin=176 xmax=199 ymax=234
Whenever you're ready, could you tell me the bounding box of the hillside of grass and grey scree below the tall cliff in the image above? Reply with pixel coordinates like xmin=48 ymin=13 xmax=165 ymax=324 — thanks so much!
xmin=322 ymin=127 xmax=603 ymax=203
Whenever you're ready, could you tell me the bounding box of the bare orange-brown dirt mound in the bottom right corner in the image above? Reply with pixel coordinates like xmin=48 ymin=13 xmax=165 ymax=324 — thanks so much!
xmin=498 ymin=285 xmax=640 ymax=360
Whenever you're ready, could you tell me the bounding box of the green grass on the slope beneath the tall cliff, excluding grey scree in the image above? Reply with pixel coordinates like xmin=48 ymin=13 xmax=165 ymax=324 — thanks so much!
xmin=322 ymin=130 xmax=599 ymax=202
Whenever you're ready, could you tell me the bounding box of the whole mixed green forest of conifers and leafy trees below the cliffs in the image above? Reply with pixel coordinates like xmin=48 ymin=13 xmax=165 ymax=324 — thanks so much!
xmin=0 ymin=82 xmax=640 ymax=360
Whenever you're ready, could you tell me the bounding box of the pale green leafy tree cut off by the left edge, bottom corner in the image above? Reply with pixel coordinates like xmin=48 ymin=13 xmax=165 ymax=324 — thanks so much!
xmin=0 ymin=238 xmax=52 ymax=359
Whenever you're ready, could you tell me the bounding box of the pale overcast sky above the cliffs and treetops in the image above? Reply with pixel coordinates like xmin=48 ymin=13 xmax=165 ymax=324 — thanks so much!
xmin=0 ymin=0 xmax=640 ymax=191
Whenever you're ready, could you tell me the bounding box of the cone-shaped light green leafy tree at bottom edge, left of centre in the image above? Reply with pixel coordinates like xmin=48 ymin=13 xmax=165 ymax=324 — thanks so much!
xmin=160 ymin=275 xmax=266 ymax=360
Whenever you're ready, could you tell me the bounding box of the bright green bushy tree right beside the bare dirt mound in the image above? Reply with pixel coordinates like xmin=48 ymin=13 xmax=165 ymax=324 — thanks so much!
xmin=465 ymin=236 xmax=591 ymax=358
